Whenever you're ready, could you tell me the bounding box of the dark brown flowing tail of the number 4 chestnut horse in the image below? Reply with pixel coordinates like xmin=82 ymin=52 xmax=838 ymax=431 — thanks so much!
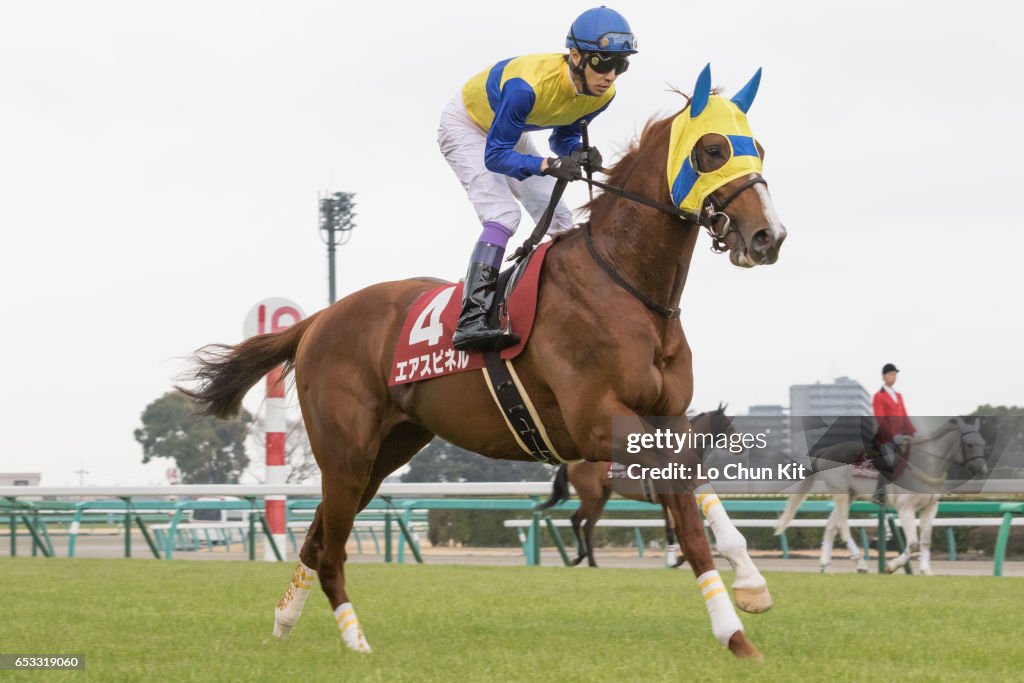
xmin=175 ymin=313 xmax=318 ymax=418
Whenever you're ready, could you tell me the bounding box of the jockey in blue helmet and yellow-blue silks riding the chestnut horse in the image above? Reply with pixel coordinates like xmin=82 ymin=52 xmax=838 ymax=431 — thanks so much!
xmin=437 ymin=7 xmax=637 ymax=350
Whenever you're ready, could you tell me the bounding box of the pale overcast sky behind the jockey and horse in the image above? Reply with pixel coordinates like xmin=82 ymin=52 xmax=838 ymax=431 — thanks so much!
xmin=0 ymin=0 xmax=1024 ymax=485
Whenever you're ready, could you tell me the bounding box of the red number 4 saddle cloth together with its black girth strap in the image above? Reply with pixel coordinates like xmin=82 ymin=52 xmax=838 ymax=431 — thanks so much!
xmin=388 ymin=242 xmax=567 ymax=465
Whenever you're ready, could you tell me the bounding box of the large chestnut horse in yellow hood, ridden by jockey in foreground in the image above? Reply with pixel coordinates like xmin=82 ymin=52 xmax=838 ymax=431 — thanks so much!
xmin=184 ymin=68 xmax=785 ymax=657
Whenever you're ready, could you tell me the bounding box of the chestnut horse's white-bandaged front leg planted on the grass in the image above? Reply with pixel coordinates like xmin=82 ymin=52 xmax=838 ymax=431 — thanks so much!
xmin=662 ymin=494 xmax=763 ymax=659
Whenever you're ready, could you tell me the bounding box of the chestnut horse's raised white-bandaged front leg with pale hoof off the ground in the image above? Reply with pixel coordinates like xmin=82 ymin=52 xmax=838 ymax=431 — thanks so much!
xmin=693 ymin=484 xmax=772 ymax=613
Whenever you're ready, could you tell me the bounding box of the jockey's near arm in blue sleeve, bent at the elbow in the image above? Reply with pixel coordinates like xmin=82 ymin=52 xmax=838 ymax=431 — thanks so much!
xmin=483 ymin=79 xmax=547 ymax=180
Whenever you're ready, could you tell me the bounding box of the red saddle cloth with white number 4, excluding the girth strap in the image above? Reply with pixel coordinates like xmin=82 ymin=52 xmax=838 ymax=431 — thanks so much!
xmin=388 ymin=242 xmax=553 ymax=386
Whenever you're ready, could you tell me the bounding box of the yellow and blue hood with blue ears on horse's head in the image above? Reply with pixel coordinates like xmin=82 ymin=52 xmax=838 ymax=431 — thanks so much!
xmin=668 ymin=65 xmax=761 ymax=214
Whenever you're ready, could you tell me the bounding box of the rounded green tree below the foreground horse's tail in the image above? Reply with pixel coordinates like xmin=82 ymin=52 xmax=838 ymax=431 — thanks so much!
xmin=135 ymin=391 xmax=253 ymax=483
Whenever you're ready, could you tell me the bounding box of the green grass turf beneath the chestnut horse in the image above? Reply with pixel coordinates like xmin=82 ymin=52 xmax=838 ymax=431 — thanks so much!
xmin=0 ymin=558 xmax=1024 ymax=682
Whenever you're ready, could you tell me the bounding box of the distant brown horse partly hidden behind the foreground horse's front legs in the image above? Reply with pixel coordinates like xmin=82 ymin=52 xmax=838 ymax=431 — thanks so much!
xmin=537 ymin=405 xmax=732 ymax=568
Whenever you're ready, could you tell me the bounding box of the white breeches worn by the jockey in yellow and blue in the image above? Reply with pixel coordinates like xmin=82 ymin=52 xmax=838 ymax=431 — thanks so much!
xmin=437 ymin=93 xmax=572 ymax=234
